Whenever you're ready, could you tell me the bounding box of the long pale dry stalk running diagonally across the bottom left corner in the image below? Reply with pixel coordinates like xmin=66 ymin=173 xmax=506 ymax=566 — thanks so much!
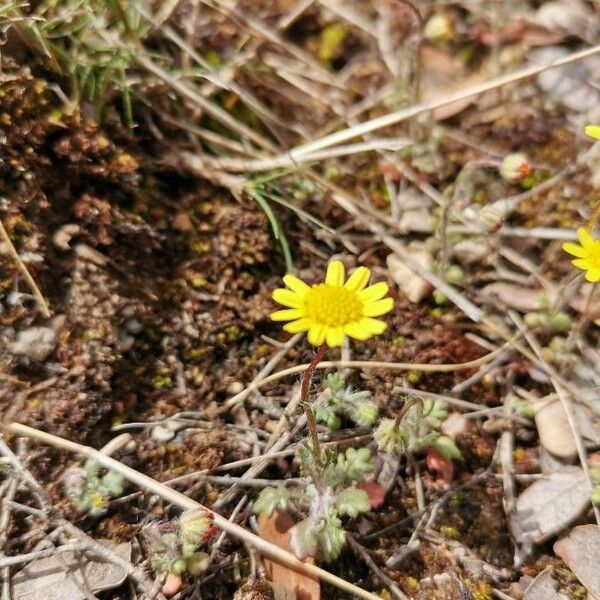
xmin=5 ymin=423 xmax=380 ymax=600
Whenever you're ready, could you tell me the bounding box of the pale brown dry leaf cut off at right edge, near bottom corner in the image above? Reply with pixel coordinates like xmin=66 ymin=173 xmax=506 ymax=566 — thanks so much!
xmin=554 ymin=525 xmax=600 ymax=600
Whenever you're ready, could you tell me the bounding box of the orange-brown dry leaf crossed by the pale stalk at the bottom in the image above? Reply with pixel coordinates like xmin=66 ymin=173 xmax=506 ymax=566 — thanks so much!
xmin=258 ymin=512 xmax=321 ymax=600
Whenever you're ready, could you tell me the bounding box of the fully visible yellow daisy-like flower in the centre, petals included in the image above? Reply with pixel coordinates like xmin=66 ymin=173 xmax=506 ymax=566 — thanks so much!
xmin=271 ymin=260 xmax=394 ymax=348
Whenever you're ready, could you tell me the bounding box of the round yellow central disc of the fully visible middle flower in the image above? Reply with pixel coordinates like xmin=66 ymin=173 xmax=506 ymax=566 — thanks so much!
xmin=304 ymin=283 xmax=363 ymax=327
